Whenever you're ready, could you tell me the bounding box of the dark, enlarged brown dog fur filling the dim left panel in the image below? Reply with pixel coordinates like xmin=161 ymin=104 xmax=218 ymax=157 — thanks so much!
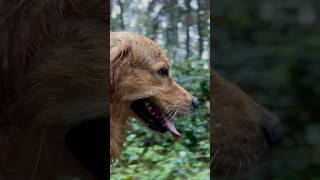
xmin=0 ymin=0 xmax=109 ymax=180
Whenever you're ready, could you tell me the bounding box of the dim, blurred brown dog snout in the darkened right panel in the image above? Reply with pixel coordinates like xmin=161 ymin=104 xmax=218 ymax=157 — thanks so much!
xmin=211 ymin=69 xmax=283 ymax=176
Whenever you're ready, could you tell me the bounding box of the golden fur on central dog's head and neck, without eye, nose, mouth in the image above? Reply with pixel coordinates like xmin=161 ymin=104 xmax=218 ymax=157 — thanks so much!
xmin=110 ymin=32 xmax=192 ymax=159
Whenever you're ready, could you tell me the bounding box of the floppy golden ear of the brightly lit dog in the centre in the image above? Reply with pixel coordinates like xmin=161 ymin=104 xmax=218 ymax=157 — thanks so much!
xmin=110 ymin=35 xmax=131 ymax=94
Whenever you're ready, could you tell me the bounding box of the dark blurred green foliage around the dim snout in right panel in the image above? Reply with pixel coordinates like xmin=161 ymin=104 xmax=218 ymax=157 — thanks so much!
xmin=211 ymin=0 xmax=320 ymax=180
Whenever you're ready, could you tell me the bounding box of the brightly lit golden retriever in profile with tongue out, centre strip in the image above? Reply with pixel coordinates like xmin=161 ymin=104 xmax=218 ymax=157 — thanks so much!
xmin=110 ymin=32 xmax=198 ymax=160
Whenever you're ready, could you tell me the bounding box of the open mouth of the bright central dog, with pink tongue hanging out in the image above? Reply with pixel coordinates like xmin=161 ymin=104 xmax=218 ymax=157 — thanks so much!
xmin=131 ymin=99 xmax=181 ymax=139
